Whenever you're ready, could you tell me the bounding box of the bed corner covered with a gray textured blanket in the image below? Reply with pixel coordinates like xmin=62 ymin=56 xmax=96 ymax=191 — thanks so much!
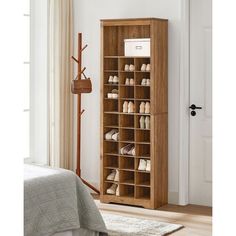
xmin=24 ymin=164 xmax=107 ymax=236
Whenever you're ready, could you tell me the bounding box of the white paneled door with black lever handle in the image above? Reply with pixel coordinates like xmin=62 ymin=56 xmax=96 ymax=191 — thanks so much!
xmin=189 ymin=0 xmax=212 ymax=206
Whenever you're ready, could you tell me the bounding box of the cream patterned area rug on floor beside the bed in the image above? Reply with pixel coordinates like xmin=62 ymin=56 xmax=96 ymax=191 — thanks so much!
xmin=101 ymin=212 xmax=183 ymax=236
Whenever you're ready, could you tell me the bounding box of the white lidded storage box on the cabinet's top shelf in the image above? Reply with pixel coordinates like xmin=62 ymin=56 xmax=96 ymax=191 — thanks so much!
xmin=124 ymin=38 xmax=150 ymax=57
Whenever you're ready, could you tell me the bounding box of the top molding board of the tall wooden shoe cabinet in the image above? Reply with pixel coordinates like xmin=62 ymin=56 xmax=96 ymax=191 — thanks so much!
xmin=101 ymin=18 xmax=168 ymax=26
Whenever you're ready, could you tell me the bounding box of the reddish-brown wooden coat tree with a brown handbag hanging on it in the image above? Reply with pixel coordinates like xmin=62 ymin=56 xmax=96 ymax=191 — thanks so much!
xmin=71 ymin=33 xmax=100 ymax=194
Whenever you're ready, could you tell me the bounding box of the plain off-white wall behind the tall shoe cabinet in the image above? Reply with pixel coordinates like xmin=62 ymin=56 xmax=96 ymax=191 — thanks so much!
xmin=74 ymin=0 xmax=181 ymax=203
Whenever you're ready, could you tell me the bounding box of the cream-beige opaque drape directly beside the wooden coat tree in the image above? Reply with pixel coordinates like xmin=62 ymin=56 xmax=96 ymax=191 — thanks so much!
xmin=49 ymin=0 xmax=73 ymax=169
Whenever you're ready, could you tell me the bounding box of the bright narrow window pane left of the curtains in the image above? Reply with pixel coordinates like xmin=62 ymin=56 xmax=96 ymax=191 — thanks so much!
xmin=22 ymin=0 xmax=30 ymax=159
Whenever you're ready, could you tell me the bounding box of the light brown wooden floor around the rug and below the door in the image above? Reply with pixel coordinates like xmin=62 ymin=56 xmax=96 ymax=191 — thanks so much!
xmin=95 ymin=195 xmax=212 ymax=236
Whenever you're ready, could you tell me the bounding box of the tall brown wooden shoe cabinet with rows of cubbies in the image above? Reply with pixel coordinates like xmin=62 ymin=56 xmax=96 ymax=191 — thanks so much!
xmin=100 ymin=18 xmax=168 ymax=209
